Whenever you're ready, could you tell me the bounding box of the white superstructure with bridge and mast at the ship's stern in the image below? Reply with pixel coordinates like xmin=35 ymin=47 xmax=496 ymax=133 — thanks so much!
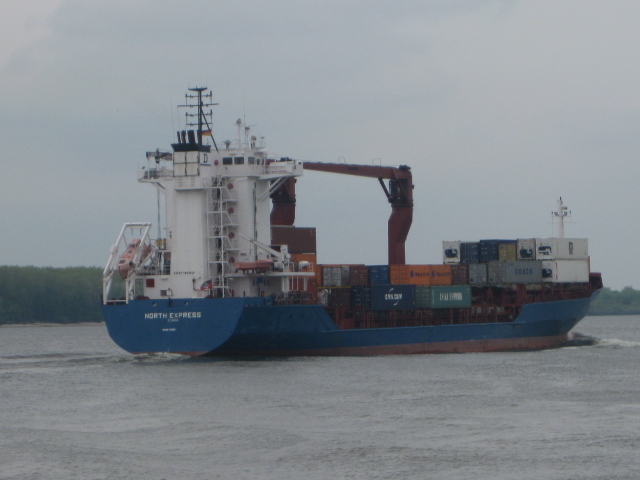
xmin=103 ymin=88 xmax=314 ymax=302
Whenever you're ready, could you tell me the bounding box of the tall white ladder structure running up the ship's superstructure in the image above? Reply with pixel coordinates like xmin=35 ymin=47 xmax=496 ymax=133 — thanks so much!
xmin=207 ymin=175 xmax=239 ymax=297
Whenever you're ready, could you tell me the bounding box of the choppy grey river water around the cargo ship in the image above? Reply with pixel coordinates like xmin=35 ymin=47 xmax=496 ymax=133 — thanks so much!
xmin=0 ymin=316 xmax=640 ymax=480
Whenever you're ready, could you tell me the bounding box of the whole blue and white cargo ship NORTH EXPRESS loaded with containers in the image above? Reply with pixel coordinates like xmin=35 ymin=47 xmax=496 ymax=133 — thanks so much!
xmin=102 ymin=87 xmax=602 ymax=356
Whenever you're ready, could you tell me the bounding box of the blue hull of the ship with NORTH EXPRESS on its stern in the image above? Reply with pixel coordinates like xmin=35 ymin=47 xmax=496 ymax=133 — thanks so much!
xmin=103 ymin=292 xmax=597 ymax=356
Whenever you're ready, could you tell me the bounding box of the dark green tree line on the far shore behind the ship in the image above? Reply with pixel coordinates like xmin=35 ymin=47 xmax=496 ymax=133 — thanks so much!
xmin=0 ymin=266 xmax=640 ymax=325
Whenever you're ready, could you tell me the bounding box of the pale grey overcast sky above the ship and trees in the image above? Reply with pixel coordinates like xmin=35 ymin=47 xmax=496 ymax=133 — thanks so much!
xmin=0 ymin=0 xmax=640 ymax=290
